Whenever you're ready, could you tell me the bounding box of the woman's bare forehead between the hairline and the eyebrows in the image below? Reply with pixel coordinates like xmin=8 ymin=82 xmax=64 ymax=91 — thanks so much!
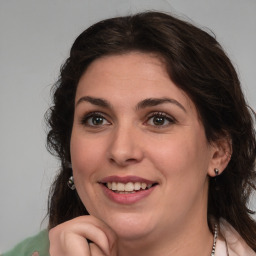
xmin=76 ymin=52 xmax=194 ymax=110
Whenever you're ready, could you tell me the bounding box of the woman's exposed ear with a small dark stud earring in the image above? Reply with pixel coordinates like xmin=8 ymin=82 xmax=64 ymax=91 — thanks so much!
xmin=208 ymin=136 xmax=232 ymax=177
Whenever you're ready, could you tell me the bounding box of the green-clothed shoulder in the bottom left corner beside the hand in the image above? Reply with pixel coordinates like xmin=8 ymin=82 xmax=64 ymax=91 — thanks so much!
xmin=1 ymin=230 xmax=49 ymax=256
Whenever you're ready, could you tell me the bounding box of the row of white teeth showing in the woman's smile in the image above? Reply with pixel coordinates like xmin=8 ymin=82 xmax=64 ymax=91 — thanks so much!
xmin=106 ymin=182 xmax=152 ymax=194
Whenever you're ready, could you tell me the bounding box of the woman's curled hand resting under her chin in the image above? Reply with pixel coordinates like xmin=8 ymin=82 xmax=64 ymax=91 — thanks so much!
xmin=49 ymin=215 xmax=117 ymax=256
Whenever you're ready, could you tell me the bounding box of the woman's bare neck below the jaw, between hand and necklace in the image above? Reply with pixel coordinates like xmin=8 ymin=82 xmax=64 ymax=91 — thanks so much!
xmin=117 ymin=180 xmax=214 ymax=256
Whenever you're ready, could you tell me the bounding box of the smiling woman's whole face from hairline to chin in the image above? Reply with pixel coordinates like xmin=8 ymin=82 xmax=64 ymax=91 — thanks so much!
xmin=71 ymin=52 xmax=214 ymax=239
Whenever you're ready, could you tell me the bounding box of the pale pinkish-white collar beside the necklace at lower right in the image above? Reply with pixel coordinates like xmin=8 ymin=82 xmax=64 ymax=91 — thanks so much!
xmin=215 ymin=219 xmax=256 ymax=256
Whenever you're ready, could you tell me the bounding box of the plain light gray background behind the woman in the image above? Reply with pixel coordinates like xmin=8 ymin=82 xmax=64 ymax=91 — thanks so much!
xmin=0 ymin=0 xmax=256 ymax=252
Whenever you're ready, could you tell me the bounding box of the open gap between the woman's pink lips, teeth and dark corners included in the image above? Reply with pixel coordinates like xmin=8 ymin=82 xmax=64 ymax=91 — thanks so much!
xmin=101 ymin=182 xmax=157 ymax=194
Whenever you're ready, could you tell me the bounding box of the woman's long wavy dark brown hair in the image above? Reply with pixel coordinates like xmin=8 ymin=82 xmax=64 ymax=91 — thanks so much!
xmin=47 ymin=12 xmax=256 ymax=251
